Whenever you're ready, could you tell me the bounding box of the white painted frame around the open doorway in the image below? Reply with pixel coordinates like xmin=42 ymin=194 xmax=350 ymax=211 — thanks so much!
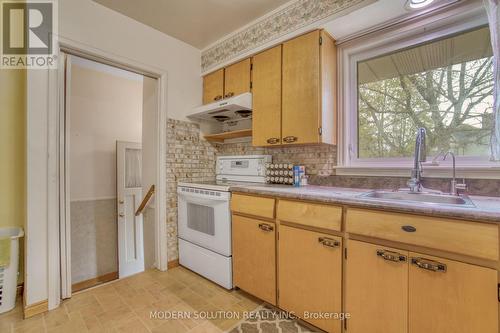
xmin=47 ymin=36 xmax=168 ymax=309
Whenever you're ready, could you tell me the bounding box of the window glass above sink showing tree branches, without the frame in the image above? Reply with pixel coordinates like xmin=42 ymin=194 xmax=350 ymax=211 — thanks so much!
xmin=357 ymin=27 xmax=494 ymax=159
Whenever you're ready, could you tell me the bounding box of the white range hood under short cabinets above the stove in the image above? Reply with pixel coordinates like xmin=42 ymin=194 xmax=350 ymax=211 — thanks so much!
xmin=188 ymin=93 xmax=252 ymax=122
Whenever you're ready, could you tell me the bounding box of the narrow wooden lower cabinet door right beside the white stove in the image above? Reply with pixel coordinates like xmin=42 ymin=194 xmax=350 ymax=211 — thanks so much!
xmin=232 ymin=215 xmax=276 ymax=305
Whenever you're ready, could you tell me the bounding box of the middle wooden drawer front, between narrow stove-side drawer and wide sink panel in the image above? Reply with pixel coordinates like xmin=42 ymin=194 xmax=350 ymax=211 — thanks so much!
xmin=277 ymin=200 xmax=342 ymax=231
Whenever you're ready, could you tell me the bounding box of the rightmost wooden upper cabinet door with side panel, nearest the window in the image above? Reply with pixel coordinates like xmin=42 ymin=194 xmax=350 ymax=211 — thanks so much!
xmin=281 ymin=30 xmax=336 ymax=144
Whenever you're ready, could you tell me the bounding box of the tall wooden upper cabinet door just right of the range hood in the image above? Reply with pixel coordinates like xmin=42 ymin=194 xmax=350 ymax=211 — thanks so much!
xmin=252 ymin=45 xmax=281 ymax=146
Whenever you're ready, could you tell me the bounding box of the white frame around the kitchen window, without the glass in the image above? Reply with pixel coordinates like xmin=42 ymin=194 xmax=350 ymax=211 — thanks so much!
xmin=336 ymin=4 xmax=500 ymax=178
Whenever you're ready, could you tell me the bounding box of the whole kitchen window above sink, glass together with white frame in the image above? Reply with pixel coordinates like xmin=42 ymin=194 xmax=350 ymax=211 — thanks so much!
xmin=339 ymin=18 xmax=500 ymax=175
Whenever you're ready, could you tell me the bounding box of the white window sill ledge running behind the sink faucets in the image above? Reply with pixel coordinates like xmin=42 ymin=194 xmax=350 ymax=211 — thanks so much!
xmin=334 ymin=165 xmax=500 ymax=179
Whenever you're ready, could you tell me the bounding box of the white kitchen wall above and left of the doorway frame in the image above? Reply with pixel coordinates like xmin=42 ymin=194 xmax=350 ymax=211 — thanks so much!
xmin=25 ymin=0 xmax=202 ymax=308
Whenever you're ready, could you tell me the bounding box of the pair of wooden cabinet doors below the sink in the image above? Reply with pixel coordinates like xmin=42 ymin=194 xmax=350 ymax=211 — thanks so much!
xmin=345 ymin=240 xmax=498 ymax=333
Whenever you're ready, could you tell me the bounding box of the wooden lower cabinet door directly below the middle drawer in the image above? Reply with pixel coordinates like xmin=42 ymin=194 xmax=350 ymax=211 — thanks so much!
xmin=278 ymin=225 xmax=342 ymax=332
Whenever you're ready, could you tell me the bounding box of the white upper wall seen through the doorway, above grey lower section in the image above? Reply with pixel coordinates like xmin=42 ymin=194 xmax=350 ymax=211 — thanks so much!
xmin=69 ymin=57 xmax=143 ymax=201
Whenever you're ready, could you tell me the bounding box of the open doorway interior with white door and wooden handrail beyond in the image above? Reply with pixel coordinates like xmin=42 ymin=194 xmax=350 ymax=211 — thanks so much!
xmin=61 ymin=53 xmax=159 ymax=298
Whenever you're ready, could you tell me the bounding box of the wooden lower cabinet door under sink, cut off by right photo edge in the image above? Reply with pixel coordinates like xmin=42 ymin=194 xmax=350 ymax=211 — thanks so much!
xmin=409 ymin=253 xmax=498 ymax=333
